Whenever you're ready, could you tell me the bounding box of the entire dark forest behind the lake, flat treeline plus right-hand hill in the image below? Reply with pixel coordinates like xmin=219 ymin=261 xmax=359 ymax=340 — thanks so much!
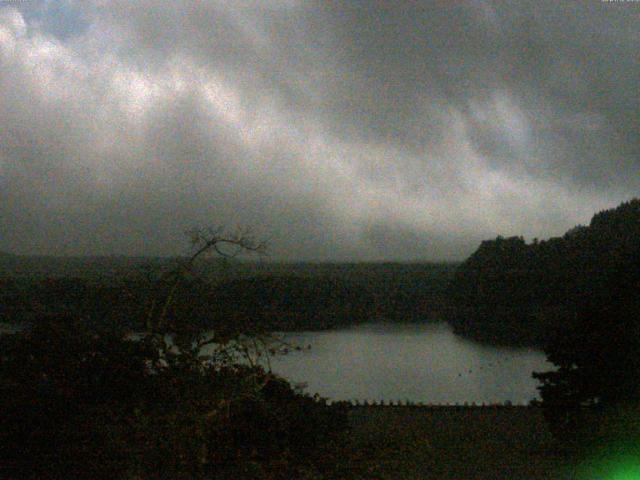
xmin=0 ymin=199 xmax=640 ymax=347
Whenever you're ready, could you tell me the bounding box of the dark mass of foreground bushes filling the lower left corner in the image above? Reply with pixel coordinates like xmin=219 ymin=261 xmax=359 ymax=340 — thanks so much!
xmin=0 ymin=317 xmax=346 ymax=479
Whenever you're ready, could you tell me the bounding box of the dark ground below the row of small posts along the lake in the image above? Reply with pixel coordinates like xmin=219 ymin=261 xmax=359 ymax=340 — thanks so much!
xmin=344 ymin=406 xmax=573 ymax=480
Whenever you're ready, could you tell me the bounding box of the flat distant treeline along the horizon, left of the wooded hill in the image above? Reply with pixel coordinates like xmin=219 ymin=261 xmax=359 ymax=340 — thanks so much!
xmin=0 ymin=256 xmax=455 ymax=330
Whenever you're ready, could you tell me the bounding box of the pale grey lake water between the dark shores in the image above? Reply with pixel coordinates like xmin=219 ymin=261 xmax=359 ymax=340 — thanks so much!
xmin=255 ymin=323 xmax=552 ymax=404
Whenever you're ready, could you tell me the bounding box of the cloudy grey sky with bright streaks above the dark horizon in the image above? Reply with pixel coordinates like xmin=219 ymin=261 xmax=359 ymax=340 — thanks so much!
xmin=0 ymin=0 xmax=640 ymax=261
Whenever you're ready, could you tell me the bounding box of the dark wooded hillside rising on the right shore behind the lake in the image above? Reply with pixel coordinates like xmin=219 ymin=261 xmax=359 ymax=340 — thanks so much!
xmin=447 ymin=199 xmax=640 ymax=345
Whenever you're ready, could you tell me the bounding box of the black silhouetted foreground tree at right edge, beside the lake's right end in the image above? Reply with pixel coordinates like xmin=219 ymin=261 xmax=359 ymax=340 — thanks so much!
xmin=533 ymin=274 xmax=640 ymax=454
